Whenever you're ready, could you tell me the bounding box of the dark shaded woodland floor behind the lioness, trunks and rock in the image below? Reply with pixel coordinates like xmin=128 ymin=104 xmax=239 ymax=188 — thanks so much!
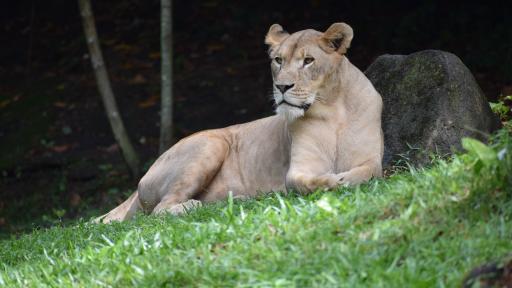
xmin=0 ymin=0 xmax=512 ymax=235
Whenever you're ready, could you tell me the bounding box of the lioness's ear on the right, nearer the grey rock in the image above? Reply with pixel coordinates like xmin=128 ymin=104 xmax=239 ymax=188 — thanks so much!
xmin=320 ymin=23 xmax=354 ymax=55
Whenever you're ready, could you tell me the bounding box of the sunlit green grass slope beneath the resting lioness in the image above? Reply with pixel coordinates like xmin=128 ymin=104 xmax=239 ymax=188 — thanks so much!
xmin=0 ymin=131 xmax=512 ymax=287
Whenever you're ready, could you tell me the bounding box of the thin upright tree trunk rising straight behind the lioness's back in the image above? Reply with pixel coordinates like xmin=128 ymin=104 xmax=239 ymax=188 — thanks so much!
xmin=160 ymin=0 xmax=173 ymax=154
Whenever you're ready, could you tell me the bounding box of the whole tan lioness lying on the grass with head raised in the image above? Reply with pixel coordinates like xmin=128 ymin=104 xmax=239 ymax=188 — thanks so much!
xmin=98 ymin=23 xmax=383 ymax=223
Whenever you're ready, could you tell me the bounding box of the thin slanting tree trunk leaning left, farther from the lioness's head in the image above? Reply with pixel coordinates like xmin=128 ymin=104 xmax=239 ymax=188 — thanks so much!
xmin=78 ymin=0 xmax=139 ymax=177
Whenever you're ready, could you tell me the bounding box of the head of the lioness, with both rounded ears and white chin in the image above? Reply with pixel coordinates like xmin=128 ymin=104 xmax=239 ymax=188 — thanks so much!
xmin=265 ymin=23 xmax=354 ymax=121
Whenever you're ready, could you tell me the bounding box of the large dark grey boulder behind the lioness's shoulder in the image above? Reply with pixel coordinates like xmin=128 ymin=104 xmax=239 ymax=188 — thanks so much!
xmin=365 ymin=50 xmax=500 ymax=167
